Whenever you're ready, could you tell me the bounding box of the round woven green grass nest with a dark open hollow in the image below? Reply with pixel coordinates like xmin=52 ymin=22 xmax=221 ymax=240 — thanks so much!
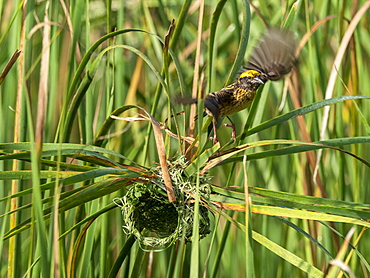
xmin=114 ymin=156 xmax=210 ymax=250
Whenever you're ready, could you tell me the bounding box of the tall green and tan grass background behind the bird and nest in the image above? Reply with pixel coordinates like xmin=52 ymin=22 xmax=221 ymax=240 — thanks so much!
xmin=0 ymin=0 xmax=370 ymax=277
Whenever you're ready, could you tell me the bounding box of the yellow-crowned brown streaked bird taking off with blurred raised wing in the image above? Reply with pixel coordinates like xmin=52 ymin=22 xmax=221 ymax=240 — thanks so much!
xmin=180 ymin=27 xmax=298 ymax=144
